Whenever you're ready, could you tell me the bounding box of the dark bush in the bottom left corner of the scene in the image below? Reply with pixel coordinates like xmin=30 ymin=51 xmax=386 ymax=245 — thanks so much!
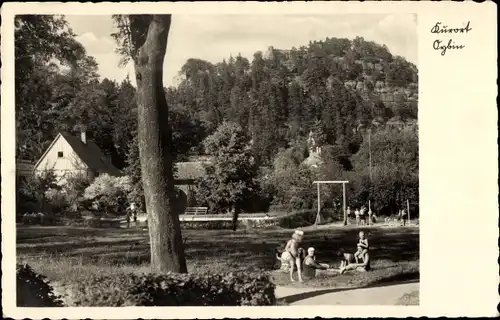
xmin=16 ymin=264 xmax=63 ymax=307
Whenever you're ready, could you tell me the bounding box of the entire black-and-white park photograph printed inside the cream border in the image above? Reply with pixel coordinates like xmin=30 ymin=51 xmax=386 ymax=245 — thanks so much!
xmin=2 ymin=1 xmax=496 ymax=317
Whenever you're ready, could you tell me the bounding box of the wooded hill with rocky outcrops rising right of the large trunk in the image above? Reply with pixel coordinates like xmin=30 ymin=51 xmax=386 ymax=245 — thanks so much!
xmin=167 ymin=38 xmax=418 ymax=164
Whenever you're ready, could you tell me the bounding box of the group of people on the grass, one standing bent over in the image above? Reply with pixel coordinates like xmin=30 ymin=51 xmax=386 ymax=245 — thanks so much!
xmin=276 ymin=230 xmax=370 ymax=282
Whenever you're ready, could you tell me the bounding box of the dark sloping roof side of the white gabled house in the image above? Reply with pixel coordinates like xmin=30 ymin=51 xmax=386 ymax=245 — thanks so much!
xmin=61 ymin=133 xmax=122 ymax=176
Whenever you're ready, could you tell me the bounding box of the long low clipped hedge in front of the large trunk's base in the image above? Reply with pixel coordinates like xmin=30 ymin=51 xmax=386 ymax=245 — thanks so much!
xmin=72 ymin=273 xmax=276 ymax=307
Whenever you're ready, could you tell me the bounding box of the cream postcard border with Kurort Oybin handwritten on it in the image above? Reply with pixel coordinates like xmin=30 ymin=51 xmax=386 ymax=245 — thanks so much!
xmin=1 ymin=1 xmax=499 ymax=319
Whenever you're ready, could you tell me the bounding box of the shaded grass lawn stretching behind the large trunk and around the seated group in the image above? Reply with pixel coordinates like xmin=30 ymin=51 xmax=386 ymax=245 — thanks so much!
xmin=17 ymin=225 xmax=419 ymax=287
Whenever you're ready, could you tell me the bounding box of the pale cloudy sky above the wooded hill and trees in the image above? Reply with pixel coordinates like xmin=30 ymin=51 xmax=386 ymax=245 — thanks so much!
xmin=66 ymin=14 xmax=417 ymax=86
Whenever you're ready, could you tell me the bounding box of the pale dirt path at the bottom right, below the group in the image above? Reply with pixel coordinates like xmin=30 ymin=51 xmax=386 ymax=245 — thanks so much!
xmin=276 ymin=282 xmax=419 ymax=305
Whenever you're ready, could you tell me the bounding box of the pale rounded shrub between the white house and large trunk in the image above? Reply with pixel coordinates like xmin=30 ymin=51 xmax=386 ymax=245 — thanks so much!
xmin=84 ymin=174 xmax=132 ymax=214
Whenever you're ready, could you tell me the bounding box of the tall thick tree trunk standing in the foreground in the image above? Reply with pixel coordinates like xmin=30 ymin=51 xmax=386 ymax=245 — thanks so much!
xmin=135 ymin=15 xmax=187 ymax=273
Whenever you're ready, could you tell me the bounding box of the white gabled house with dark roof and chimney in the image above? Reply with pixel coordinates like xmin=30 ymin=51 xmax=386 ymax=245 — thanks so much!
xmin=34 ymin=132 xmax=122 ymax=179
